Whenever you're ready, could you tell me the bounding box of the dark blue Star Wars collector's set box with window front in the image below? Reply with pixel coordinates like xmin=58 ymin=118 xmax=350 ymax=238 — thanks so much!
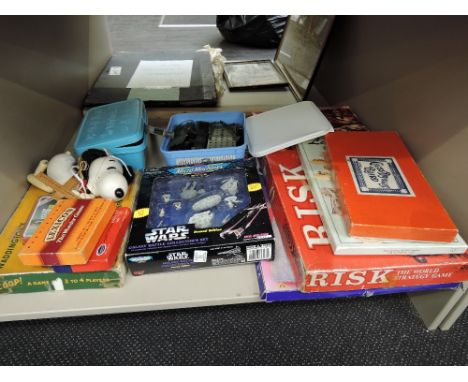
xmin=126 ymin=158 xmax=274 ymax=275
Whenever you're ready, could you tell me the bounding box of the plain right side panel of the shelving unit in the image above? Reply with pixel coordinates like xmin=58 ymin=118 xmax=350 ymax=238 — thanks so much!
xmin=315 ymin=16 xmax=468 ymax=239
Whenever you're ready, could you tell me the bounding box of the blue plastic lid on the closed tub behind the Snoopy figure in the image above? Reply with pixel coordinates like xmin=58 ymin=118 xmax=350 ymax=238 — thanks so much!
xmin=74 ymin=98 xmax=146 ymax=154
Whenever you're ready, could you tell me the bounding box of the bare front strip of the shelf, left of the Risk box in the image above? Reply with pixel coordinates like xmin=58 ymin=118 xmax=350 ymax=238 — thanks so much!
xmin=0 ymin=264 xmax=261 ymax=321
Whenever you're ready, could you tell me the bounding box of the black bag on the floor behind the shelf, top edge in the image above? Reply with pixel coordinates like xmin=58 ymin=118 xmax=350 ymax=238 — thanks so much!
xmin=216 ymin=16 xmax=288 ymax=48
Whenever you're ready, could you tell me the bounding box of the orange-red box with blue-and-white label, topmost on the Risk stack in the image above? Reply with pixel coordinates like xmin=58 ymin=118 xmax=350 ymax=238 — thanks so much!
xmin=325 ymin=131 xmax=458 ymax=242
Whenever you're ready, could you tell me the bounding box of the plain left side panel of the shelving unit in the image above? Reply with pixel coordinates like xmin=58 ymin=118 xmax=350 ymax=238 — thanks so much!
xmin=0 ymin=16 xmax=111 ymax=228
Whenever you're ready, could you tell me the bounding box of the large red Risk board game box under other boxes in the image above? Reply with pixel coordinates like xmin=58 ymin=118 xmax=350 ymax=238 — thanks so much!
xmin=264 ymin=146 xmax=468 ymax=292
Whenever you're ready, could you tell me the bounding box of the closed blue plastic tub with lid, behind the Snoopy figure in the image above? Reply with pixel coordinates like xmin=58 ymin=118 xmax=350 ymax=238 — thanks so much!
xmin=73 ymin=99 xmax=148 ymax=170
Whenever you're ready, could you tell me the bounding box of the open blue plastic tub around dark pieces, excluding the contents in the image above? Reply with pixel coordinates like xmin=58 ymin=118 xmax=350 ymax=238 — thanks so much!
xmin=161 ymin=111 xmax=247 ymax=166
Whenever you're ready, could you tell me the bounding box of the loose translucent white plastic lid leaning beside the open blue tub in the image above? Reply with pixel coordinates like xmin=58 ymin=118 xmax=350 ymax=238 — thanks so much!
xmin=246 ymin=101 xmax=333 ymax=157
